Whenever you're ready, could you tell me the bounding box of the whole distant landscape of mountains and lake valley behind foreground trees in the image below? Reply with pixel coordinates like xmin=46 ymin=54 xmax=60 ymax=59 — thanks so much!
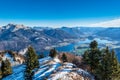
xmin=0 ymin=24 xmax=120 ymax=60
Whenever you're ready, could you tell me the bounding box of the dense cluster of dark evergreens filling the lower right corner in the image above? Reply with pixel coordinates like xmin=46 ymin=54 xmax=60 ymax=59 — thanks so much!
xmin=83 ymin=40 xmax=120 ymax=80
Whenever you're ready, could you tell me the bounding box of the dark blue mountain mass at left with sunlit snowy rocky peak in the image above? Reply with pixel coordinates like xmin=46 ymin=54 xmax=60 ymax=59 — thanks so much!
xmin=0 ymin=24 xmax=77 ymax=51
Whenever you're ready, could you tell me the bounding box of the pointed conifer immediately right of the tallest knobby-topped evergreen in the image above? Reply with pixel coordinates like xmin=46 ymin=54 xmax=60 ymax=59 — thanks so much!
xmin=96 ymin=47 xmax=111 ymax=80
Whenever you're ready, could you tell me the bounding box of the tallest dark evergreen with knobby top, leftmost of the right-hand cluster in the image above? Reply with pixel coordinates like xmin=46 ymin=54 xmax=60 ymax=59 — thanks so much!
xmin=83 ymin=40 xmax=101 ymax=73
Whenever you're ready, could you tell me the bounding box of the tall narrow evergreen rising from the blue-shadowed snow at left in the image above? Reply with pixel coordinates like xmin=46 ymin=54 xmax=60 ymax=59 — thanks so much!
xmin=25 ymin=46 xmax=39 ymax=80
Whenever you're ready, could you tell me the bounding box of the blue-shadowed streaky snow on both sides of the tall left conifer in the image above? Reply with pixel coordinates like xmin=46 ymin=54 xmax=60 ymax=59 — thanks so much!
xmin=3 ymin=57 xmax=61 ymax=80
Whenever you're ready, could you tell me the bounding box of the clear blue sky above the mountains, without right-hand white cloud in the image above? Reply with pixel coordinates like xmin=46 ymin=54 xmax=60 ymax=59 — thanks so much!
xmin=0 ymin=0 xmax=120 ymax=27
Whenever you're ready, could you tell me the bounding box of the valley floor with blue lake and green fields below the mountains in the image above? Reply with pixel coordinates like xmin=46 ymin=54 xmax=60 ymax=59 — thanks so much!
xmin=43 ymin=38 xmax=120 ymax=61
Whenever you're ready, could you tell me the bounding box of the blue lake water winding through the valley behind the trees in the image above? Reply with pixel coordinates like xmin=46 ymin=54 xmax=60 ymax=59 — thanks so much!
xmin=44 ymin=38 xmax=120 ymax=61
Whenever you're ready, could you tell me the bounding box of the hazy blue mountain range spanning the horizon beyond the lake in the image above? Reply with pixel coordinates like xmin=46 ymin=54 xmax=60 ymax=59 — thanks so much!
xmin=0 ymin=24 xmax=120 ymax=52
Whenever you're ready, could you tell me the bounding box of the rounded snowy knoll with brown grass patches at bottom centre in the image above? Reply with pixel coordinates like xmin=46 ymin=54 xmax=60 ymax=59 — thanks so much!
xmin=48 ymin=63 xmax=94 ymax=80
